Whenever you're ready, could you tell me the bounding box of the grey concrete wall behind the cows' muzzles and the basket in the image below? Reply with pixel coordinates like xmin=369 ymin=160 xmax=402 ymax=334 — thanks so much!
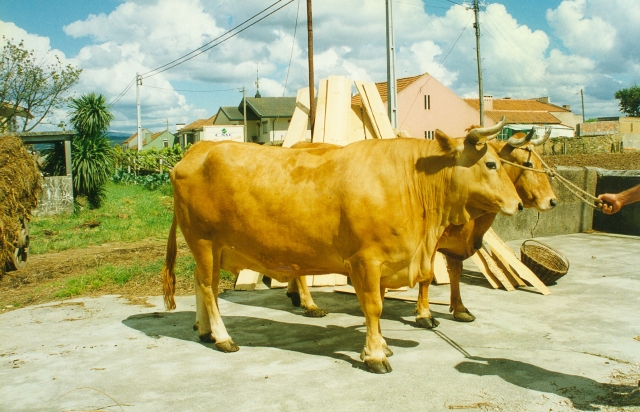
xmin=492 ymin=167 xmax=600 ymax=240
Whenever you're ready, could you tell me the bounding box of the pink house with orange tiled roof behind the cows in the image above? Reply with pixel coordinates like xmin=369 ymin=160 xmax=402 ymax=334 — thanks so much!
xmin=352 ymin=73 xmax=496 ymax=139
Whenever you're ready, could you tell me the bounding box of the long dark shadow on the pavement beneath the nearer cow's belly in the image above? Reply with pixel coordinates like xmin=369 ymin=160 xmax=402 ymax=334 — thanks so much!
xmin=122 ymin=311 xmax=418 ymax=370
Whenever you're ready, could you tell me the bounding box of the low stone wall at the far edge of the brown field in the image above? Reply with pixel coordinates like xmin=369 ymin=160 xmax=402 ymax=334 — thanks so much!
xmin=537 ymin=134 xmax=626 ymax=155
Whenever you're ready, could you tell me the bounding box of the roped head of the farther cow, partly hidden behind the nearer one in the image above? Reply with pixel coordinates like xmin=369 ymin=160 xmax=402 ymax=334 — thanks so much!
xmin=491 ymin=128 xmax=557 ymax=212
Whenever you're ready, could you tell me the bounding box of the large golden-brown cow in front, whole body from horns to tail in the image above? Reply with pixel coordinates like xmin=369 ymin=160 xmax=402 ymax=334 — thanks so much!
xmin=163 ymin=122 xmax=522 ymax=373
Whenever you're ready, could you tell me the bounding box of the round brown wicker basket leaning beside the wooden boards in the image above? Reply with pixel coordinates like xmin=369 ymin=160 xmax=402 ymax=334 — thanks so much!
xmin=520 ymin=239 xmax=569 ymax=285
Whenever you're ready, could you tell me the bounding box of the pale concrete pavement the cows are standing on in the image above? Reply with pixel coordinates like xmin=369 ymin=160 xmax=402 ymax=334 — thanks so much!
xmin=0 ymin=234 xmax=640 ymax=411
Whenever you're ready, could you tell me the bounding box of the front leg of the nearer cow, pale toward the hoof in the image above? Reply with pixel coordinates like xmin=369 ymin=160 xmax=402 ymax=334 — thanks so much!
xmin=348 ymin=261 xmax=391 ymax=373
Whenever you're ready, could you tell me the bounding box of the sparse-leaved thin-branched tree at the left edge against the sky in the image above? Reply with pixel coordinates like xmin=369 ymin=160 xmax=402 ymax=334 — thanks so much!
xmin=0 ymin=36 xmax=82 ymax=132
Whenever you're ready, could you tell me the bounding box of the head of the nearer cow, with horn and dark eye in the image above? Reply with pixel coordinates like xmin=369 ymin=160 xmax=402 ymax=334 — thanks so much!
xmin=435 ymin=118 xmax=523 ymax=224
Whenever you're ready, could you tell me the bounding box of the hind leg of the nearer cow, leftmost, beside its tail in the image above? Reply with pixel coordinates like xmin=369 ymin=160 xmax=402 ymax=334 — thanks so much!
xmin=191 ymin=241 xmax=239 ymax=352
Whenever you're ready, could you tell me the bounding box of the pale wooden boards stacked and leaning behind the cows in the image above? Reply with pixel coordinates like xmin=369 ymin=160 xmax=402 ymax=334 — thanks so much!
xmin=235 ymin=76 xmax=550 ymax=295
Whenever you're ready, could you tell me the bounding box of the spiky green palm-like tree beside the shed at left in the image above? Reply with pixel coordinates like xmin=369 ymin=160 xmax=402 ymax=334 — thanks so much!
xmin=43 ymin=92 xmax=115 ymax=208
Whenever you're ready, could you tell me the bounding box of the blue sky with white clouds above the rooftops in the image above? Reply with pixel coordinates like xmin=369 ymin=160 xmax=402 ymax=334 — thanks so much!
xmin=0 ymin=0 xmax=640 ymax=132
